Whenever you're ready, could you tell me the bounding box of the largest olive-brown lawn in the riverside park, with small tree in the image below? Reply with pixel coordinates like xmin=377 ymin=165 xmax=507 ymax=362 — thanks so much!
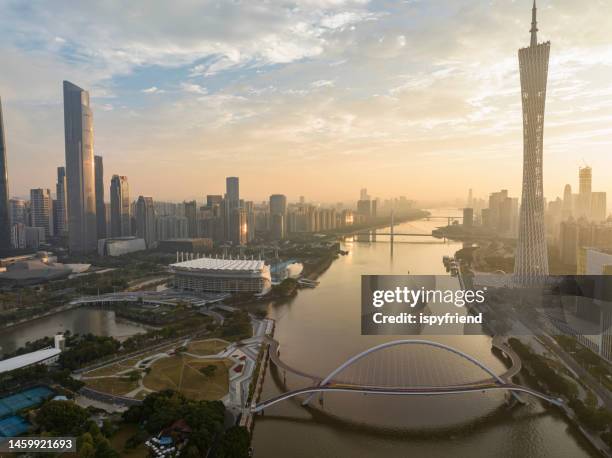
xmin=143 ymin=355 xmax=232 ymax=401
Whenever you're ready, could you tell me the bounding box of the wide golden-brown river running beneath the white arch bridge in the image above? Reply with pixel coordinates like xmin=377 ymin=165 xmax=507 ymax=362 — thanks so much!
xmin=253 ymin=210 xmax=597 ymax=458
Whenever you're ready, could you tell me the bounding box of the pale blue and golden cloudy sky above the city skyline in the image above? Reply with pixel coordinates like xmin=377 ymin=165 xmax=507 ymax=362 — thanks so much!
xmin=0 ymin=0 xmax=612 ymax=202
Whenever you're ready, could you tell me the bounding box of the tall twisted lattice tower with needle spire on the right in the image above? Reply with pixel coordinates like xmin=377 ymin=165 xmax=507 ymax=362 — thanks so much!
xmin=514 ymin=0 xmax=550 ymax=286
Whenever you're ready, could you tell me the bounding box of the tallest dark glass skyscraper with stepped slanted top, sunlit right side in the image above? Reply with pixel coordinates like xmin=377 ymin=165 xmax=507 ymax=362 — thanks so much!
xmin=64 ymin=81 xmax=98 ymax=253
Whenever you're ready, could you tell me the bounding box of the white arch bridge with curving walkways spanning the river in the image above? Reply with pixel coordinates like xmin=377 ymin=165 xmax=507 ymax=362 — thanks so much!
xmin=250 ymin=339 xmax=563 ymax=413
